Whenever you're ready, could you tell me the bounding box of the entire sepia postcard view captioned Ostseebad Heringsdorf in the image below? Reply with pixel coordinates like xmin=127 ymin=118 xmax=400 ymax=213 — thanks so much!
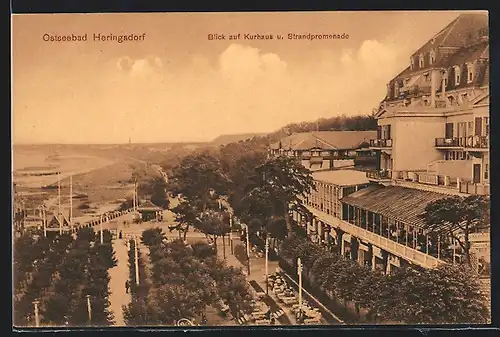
xmin=11 ymin=11 xmax=491 ymax=330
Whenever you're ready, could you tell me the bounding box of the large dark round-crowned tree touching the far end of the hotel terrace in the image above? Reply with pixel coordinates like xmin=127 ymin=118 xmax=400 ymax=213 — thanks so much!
xmin=247 ymin=156 xmax=315 ymax=235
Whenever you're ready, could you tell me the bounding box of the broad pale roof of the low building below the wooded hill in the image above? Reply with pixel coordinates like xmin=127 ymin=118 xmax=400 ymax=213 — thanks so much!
xmin=271 ymin=131 xmax=377 ymax=150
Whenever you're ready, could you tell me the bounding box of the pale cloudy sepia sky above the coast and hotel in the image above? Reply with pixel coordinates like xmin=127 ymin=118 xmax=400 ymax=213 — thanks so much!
xmin=12 ymin=11 xmax=480 ymax=144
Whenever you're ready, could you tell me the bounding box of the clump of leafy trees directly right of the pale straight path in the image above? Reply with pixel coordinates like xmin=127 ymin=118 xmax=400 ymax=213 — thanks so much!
xmin=125 ymin=228 xmax=251 ymax=325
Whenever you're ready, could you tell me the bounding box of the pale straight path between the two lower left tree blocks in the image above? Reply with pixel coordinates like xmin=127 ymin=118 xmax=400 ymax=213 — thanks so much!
xmin=109 ymin=239 xmax=131 ymax=326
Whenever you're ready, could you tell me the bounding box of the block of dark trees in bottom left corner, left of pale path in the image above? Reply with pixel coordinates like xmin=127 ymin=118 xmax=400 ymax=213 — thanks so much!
xmin=14 ymin=228 xmax=116 ymax=326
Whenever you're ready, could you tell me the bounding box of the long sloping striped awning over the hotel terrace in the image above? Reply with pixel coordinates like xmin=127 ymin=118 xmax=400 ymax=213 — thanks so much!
xmin=340 ymin=185 xmax=446 ymax=228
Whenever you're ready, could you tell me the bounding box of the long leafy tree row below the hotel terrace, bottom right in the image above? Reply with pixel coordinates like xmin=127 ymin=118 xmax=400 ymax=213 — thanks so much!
xmin=280 ymin=237 xmax=489 ymax=324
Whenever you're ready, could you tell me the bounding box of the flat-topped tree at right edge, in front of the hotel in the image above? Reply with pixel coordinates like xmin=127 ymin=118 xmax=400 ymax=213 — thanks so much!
xmin=421 ymin=195 xmax=490 ymax=266
